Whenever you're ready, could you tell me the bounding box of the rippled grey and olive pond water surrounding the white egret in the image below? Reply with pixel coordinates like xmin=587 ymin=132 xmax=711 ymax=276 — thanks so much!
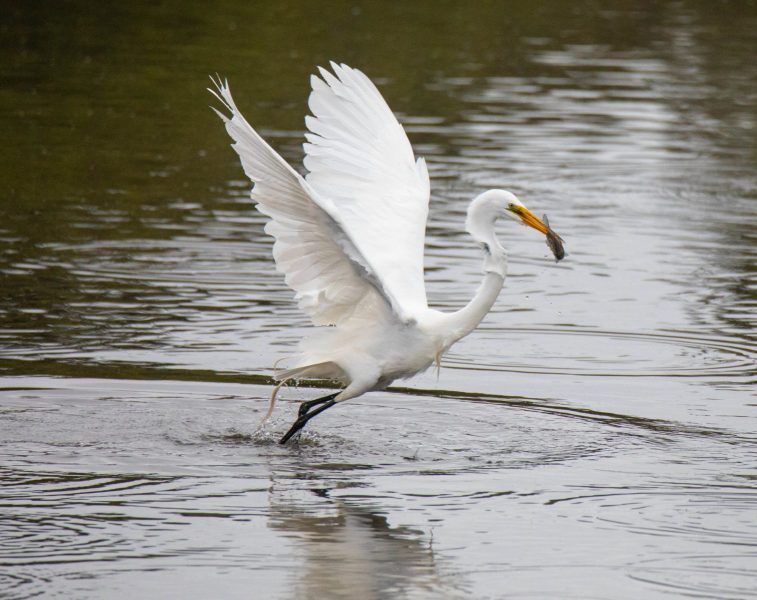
xmin=0 ymin=0 xmax=757 ymax=599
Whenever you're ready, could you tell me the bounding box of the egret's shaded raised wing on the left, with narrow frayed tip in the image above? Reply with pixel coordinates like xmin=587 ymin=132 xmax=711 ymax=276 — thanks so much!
xmin=209 ymin=79 xmax=389 ymax=325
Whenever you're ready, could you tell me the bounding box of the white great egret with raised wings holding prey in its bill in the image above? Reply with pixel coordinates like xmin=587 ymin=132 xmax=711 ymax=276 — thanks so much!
xmin=209 ymin=62 xmax=563 ymax=444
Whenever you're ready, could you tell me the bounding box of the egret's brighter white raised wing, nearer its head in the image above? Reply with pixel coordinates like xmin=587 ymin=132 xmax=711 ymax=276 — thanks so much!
xmin=304 ymin=62 xmax=430 ymax=319
